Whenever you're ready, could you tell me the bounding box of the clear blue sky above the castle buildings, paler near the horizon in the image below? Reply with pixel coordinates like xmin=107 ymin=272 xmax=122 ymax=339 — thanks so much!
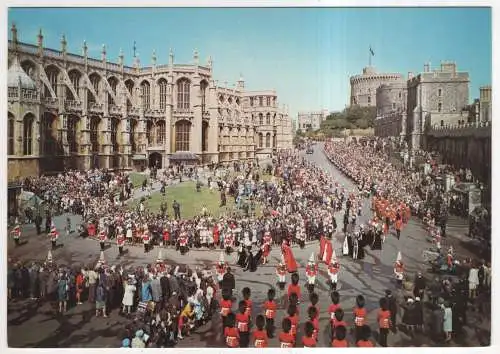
xmin=8 ymin=8 xmax=492 ymax=117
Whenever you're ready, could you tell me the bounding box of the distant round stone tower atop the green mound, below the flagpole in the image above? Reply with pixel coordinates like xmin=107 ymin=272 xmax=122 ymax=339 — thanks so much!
xmin=350 ymin=66 xmax=404 ymax=107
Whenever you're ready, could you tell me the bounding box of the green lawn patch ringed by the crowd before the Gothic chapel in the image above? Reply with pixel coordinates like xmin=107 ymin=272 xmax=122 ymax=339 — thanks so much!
xmin=129 ymin=181 xmax=261 ymax=219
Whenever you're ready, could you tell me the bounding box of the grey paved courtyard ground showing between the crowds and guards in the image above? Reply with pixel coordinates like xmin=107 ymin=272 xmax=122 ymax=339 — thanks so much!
xmin=7 ymin=147 xmax=490 ymax=347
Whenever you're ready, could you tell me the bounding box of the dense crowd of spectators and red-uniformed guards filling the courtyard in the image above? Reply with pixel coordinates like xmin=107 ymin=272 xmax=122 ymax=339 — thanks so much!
xmin=8 ymin=142 xmax=491 ymax=348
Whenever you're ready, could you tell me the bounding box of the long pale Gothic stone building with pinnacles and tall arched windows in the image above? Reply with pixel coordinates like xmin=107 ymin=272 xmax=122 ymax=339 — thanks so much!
xmin=7 ymin=26 xmax=293 ymax=180
